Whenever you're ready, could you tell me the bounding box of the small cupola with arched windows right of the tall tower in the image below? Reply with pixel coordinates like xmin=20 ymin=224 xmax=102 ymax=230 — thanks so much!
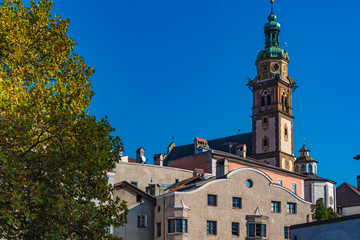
xmin=294 ymin=144 xmax=317 ymax=175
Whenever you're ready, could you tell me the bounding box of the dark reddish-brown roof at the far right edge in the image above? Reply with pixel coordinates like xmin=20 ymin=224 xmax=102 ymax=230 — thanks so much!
xmin=336 ymin=183 xmax=360 ymax=207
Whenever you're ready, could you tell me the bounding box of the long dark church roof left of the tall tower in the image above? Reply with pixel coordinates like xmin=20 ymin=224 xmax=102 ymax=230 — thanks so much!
xmin=165 ymin=133 xmax=252 ymax=163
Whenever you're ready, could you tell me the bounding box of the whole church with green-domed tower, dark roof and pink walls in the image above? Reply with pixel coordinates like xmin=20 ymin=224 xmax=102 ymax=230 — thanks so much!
xmin=160 ymin=0 xmax=336 ymax=206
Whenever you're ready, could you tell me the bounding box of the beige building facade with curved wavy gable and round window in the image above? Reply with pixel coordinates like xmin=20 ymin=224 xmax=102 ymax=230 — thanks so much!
xmin=154 ymin=168 xmax=311 ymax=240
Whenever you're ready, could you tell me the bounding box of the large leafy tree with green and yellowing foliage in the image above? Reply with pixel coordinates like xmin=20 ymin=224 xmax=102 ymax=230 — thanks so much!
xmin=0 ymin=0 xmax=127 ymax=239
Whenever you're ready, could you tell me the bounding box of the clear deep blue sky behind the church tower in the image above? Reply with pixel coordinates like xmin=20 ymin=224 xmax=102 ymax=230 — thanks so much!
xmin=54 ymin=0 xmax=360 ymax=188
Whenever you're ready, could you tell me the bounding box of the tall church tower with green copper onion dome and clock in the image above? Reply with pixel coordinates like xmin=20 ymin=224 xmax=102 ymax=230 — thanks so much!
xmin=249 ymin=0 xmax=296 ymax=171
